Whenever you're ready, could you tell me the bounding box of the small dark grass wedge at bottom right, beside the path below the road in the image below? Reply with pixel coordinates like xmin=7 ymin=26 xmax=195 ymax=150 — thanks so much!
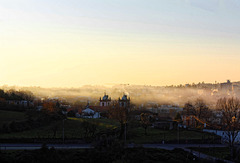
xmin=189 ymin=147 xmax=230 ymax=159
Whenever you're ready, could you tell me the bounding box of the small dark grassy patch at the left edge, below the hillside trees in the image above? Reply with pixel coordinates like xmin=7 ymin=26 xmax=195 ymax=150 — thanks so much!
xmin=0 ymin=110 xmax=25 ymax=127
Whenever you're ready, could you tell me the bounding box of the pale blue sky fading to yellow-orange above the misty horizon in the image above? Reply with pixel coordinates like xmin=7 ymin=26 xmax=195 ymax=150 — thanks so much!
xmin=0 ymin=0 xmax=240 ymax=87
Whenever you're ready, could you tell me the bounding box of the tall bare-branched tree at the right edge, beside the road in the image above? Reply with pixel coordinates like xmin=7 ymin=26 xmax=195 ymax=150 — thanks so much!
xmin=216 ymin=97 xmax=240 ymax=158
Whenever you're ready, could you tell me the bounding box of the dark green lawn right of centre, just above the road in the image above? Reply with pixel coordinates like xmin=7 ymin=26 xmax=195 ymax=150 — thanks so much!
xmin=128 ymin=127 xmax=217 ymax=144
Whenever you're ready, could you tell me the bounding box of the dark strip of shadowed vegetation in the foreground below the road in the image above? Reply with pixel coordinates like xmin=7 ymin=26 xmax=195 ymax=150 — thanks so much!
xmin=0 ymin=143 xmax=200 ymax=163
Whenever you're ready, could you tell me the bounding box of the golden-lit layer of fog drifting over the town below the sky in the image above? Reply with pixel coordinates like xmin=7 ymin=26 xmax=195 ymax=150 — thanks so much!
xmin=0 ymin=84 xmax=240 ymax=108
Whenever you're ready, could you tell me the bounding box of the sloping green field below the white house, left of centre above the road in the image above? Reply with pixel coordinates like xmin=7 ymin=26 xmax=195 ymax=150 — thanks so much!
xmin=0 ymin=118 xmax=118 ymax=138
